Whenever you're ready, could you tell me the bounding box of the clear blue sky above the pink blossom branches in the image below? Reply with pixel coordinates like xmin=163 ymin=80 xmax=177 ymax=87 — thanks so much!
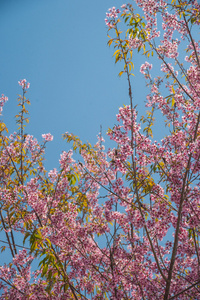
xmin=0 ymin=0 xmax=153 ymax=169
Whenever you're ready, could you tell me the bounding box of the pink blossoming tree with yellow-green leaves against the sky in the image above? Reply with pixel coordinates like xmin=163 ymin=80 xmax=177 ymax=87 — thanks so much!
xmin=0 ymin=0 xmax=200 ymax=300
